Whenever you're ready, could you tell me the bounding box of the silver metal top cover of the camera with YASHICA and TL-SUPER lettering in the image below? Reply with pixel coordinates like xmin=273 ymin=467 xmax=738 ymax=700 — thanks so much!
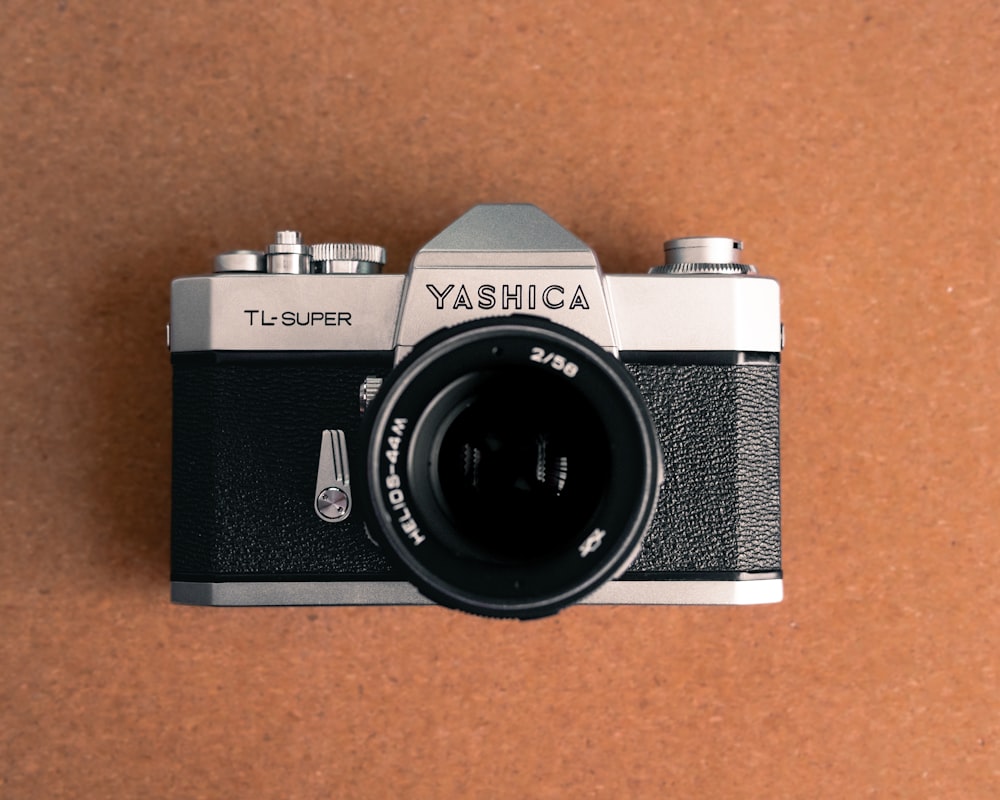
xmin=171 ymin=205 xmax=781 ymax=354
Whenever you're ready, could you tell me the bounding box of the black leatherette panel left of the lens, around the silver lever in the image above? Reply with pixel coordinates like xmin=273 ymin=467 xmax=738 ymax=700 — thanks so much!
xmin=171 ymin=354 xmax=391 ymax=580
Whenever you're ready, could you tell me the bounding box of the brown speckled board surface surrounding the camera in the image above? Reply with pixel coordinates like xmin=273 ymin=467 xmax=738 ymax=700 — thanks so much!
xmin=0 ymin=0 xmax=1000 ymax=798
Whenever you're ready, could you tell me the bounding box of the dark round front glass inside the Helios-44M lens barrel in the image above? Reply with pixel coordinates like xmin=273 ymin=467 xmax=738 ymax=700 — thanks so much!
xmin=416 ymin=368 xmax=610 ymax=564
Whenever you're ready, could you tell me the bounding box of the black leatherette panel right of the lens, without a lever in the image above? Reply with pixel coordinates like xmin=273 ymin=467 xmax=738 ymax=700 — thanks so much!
xmin=623 ymin=363 xmax=781 ymax=578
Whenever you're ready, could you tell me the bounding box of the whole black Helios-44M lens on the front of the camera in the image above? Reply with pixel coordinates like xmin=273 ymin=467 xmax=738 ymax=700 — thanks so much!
xmin=366 ymin=317 xmax=660 ymax=617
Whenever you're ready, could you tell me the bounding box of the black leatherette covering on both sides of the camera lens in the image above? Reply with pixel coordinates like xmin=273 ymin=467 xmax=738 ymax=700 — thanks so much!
xmin=171 ymin=354 xmax=781 ymax=580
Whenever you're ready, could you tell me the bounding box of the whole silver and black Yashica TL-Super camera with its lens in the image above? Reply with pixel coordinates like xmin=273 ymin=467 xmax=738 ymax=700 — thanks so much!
xmin=167 ymin=204 xmax=784 ymax=619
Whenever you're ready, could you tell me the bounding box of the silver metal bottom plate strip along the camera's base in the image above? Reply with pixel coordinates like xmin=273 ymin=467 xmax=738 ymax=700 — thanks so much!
xmin=170 ymin=578 xmax=783 ymax=606
